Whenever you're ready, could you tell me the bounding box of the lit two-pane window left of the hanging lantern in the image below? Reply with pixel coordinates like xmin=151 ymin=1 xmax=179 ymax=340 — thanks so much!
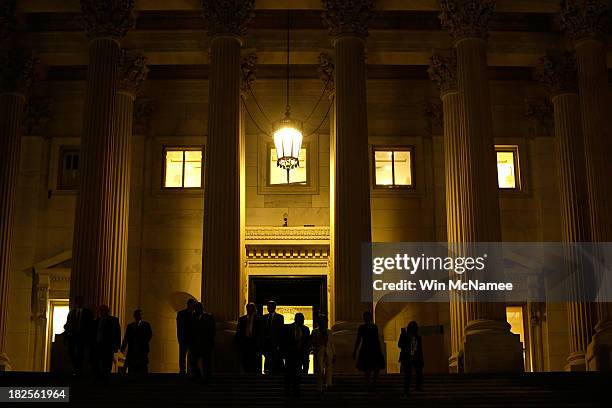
xmin=164 ymin=148 xmax=202 ymax=188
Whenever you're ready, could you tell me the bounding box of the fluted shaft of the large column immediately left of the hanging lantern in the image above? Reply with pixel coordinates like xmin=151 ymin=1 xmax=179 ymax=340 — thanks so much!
xmin=202 ymin=36 xmax=241 ymax=321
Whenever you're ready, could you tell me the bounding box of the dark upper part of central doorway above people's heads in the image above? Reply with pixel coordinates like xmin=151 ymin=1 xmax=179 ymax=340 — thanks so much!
xmin=249 ymin=276 xmax=327 ymax=318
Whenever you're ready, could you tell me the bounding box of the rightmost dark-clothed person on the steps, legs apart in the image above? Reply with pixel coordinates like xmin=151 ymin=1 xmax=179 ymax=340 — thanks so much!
xmin=397 ymin=320 xmax=425 ymax=396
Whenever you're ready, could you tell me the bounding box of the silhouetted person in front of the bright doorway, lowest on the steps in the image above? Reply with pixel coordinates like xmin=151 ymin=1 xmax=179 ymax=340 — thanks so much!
xmin=281 ymin=313 xmax=310 ymax=397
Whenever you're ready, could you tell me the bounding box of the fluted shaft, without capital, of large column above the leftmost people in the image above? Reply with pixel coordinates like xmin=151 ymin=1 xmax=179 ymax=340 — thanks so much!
xmin=70 ymin=38 xmax=123 ymax=314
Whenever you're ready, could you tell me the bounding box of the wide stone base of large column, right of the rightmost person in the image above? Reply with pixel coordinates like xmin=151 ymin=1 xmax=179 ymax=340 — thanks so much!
xmin=464 ymin=320 xmax=525 ymax=373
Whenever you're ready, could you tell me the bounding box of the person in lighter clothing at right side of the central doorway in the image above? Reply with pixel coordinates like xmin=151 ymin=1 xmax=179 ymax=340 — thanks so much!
xmin=310 ymin=315 xmax=336 ymax=392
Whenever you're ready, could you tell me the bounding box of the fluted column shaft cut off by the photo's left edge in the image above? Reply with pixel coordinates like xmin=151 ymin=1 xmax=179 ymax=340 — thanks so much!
xmin=0 ymin=93 xmax=25 ymax=354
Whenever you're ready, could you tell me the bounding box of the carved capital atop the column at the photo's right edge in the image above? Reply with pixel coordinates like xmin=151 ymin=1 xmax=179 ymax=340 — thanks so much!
xmin=561 ymin=0 xmax=610 ymax=41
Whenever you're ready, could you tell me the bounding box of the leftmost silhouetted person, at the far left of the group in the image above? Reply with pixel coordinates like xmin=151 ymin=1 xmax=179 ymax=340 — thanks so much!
xmin=64 ymin=296 xmax=94 ymax=375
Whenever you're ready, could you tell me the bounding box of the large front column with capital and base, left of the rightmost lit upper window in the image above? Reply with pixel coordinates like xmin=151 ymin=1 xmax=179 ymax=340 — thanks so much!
xmin=440 ymin=0 xmax=523 ymax=372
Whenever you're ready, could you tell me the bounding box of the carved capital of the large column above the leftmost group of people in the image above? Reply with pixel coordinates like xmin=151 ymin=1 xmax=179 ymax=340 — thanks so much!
xmin=81 ymin=0 xmax=134 ymax=40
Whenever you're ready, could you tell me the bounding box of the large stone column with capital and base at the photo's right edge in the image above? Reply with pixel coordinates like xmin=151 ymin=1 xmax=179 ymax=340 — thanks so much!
xmin=561 ymin=0 xmax=612 ymax=370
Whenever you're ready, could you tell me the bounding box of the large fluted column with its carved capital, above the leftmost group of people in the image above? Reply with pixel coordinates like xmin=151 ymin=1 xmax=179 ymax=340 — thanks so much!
xmin=70 ymin=0 xmax=134 ymax=315
